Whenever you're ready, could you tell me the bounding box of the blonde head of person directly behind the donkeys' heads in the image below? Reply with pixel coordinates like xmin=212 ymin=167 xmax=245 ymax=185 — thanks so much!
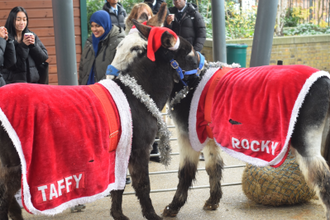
xmin=125 ymin=3 xmax=153 ymax=35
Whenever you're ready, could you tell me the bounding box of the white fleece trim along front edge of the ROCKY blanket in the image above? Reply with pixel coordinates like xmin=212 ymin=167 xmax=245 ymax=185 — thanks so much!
xmin=188 ymin=68 xmax=219 ymax=151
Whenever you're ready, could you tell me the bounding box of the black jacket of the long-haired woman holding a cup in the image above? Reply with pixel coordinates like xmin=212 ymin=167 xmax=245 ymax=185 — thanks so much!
xmin=2 ymin=32 xmax=48 ymax=83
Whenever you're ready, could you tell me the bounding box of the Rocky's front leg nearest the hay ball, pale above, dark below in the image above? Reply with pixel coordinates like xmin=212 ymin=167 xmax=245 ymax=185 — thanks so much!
xmin=203 ymin=140 xmax=224 ymax=210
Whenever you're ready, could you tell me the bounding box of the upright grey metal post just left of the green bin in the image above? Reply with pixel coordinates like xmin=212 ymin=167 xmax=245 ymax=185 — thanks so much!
xmin=211 ymin=0 xmax=227 ymax=63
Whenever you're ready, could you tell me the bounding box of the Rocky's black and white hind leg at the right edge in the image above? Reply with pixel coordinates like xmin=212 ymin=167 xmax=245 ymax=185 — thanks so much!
xmin=291 ymin=78 xmax=330 ymax=220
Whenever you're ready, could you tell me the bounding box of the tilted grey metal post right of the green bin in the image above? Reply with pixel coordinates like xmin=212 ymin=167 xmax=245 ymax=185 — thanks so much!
xmin=250 ymin=0 xmax=278 ymax=67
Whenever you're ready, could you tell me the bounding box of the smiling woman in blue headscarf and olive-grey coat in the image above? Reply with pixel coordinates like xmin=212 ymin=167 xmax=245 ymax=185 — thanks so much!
xmin=79 ymin=10 xmax=125 ymax=85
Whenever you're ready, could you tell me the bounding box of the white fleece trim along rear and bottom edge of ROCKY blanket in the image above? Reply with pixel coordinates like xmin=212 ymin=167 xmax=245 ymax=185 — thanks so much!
xmin=214 ymin=71 xmax=330 ymax=166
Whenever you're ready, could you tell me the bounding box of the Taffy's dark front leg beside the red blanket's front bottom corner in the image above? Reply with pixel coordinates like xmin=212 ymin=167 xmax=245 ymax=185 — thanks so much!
xmin=110 ymin=190 xmax=129 ymax=220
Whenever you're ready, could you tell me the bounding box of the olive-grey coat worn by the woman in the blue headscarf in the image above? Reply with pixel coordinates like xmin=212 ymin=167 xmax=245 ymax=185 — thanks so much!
xmin=79 ymin=25 xmax=126 ymax=85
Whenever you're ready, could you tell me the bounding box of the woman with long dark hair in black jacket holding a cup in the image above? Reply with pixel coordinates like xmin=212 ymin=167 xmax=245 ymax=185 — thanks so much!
xmin=2 ymin=7 xmax=48 ymax=83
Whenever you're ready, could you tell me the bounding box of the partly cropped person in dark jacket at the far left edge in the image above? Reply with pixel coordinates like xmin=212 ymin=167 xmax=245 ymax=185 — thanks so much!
xmin=0 ymin=26 xmax=16 ymax=87
